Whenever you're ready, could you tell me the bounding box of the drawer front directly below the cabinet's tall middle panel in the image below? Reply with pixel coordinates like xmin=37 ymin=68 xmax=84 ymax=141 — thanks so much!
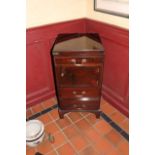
xmin=59 ymin=88 xmax=100 ymax=99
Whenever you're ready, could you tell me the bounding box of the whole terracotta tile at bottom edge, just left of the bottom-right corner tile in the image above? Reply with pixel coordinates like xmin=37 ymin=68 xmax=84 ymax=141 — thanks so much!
xmin=94 ymin=139 xmax=114 ymax=154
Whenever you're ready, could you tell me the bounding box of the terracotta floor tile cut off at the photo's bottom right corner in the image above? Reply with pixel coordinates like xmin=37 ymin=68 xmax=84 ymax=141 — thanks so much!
xmin=118 ymin=140 xmax=129 ymax=155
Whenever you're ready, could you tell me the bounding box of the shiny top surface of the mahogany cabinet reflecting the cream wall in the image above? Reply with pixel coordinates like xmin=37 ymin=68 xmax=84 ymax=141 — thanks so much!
xmin=52 ymin=33 xmax=104 ymax=53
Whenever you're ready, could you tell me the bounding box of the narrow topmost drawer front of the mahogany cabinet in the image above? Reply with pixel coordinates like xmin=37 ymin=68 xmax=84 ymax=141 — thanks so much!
xmin=55 ymin=57 xmax=103 ymax=65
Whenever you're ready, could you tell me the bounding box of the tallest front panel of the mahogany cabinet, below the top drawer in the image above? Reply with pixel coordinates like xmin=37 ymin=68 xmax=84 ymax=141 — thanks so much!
xmin=56 ymin=65 xmax=101 ymax=87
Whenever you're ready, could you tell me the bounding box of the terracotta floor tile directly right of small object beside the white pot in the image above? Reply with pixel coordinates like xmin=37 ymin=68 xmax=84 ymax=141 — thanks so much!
xmin=52 ymin=132 xmax=66 ymax=148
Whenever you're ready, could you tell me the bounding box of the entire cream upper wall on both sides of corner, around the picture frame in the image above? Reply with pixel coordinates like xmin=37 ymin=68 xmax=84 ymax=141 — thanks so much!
xmin=26 ymin=0 xmax=128 ymax=29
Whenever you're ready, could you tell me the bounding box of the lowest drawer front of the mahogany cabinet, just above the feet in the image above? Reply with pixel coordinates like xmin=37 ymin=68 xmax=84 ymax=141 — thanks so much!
xmin=59 ymin=99 xmax=100 ymax=110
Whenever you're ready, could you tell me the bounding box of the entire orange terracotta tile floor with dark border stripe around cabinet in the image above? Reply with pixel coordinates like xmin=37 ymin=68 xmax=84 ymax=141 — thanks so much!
xmin=26 ymin=98 xmax=129 ymax=155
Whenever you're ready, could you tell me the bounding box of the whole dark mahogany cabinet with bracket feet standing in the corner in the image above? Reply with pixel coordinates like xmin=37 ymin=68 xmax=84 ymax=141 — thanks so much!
xmin=51 ymin=33 xmax=104 ymax=118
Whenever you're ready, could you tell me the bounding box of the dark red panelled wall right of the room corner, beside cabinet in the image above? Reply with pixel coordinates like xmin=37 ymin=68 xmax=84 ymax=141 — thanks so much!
xmin=86 ymin=19 xmax=129 ymax=115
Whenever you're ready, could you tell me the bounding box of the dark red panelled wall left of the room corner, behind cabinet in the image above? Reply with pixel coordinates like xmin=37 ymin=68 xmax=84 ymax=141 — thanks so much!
xmin=26 ymin=19 xmax=85 ymax=108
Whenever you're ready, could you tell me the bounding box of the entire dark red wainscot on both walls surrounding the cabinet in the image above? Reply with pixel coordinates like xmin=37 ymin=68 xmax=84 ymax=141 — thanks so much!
xmin=26 ymin=19 xmax=129 ymax=115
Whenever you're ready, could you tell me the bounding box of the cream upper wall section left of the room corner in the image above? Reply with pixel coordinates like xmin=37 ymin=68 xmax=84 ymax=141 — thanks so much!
xmin=26 ymin=0 xmax=86 ymax=28
